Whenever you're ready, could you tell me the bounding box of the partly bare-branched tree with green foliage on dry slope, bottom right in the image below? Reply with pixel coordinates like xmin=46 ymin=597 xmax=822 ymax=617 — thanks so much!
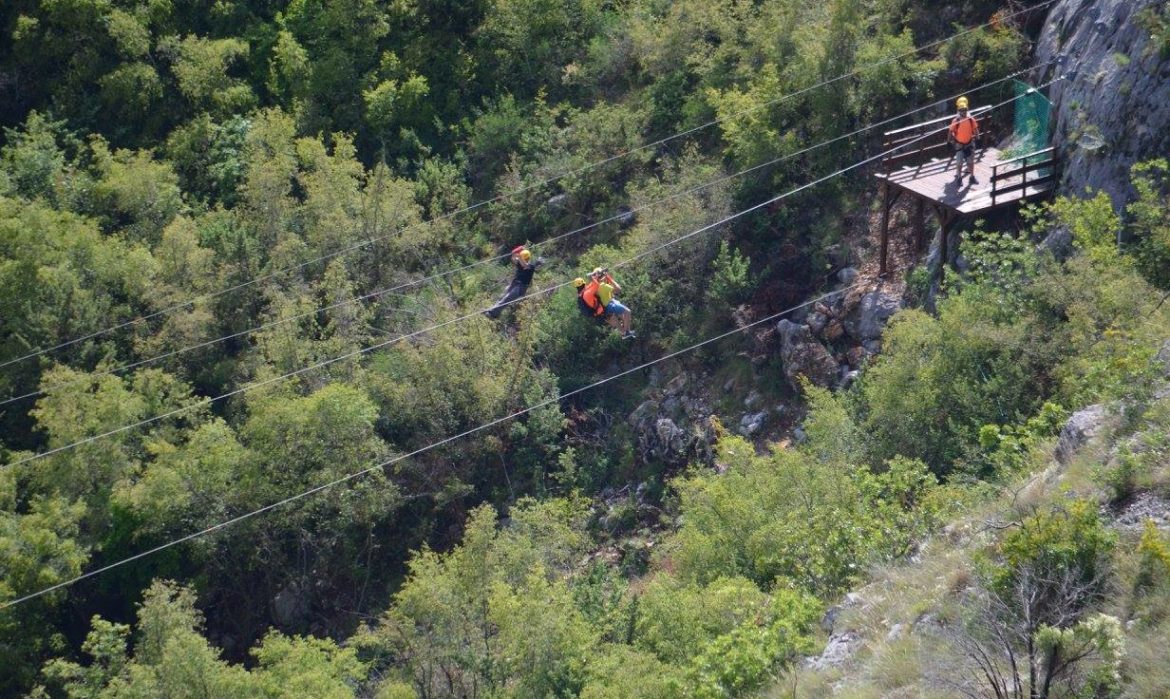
xmin=940 ymin=500 xmax=1121 ymax=699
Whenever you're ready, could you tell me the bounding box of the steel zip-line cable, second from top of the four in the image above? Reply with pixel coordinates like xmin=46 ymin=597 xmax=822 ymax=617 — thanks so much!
xmin=0 ymin=61 xmax=1055 ymax=406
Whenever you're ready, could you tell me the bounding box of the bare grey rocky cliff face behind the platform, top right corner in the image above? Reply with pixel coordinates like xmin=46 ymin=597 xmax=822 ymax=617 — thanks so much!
xmin=1037 ymin=0 xmax=1170 ymax=210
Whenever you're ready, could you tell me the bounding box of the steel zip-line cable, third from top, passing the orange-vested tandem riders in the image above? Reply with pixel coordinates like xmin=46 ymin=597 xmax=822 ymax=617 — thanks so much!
xmin=0 ymin=74 xmax=1065 ymax=467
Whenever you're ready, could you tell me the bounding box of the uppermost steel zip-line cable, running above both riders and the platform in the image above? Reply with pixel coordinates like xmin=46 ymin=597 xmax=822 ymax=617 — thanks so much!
xmin=0 ymin=0 xmax=1057 ymax=369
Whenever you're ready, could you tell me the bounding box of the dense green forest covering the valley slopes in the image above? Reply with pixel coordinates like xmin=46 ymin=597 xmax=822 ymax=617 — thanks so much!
xmin=0 ymin=0 xmax=1170 ymax=699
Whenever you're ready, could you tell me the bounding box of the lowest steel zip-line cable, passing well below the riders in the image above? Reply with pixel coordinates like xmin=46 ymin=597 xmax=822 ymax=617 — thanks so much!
xmin=0 ymin=277 xmax=863 ymax=611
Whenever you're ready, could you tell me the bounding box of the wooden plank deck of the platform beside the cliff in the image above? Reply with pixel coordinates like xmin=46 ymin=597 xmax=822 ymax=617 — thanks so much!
xmin=876 ymin=148 xmax=1054 ymax=214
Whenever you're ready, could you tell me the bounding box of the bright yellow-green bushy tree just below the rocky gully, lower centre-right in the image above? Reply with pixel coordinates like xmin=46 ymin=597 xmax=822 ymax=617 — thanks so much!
xmin=666 ymin=438 xmax=937 ymax=595
